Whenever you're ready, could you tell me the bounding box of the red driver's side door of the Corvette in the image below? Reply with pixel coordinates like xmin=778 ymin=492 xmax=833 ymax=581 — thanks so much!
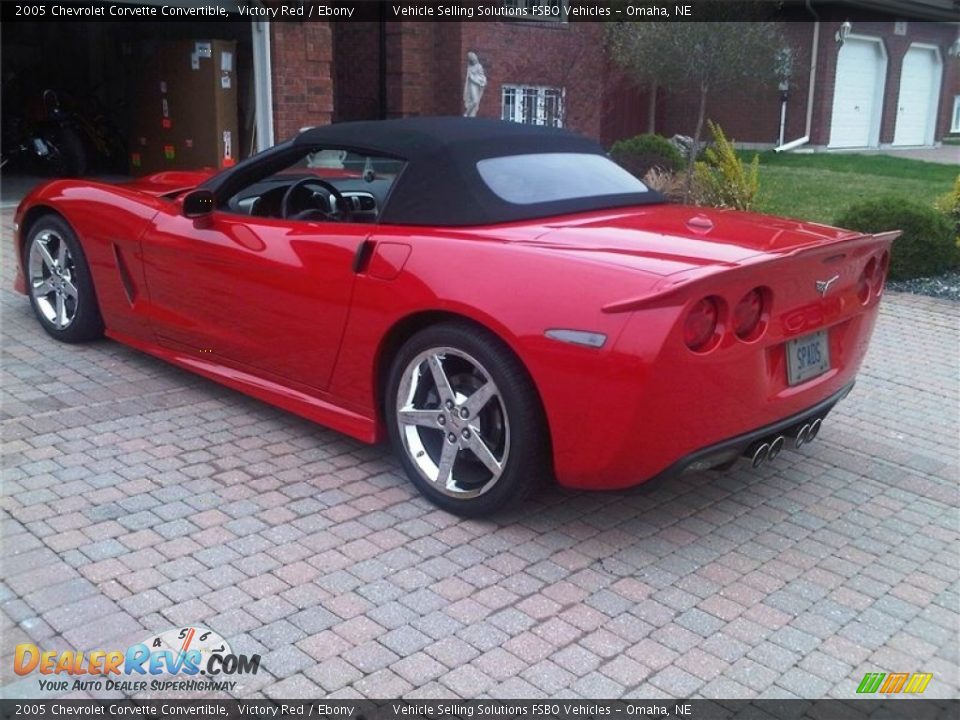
xmin=142 ymin=208 xmax=370 ymax=389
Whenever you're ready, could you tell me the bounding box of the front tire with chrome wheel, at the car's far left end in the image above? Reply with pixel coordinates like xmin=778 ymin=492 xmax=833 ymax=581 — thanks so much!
xmin=24 ymin=215 xmax=103 ymax=343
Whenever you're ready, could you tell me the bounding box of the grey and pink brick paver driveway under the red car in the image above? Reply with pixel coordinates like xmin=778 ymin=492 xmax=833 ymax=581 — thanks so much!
xmin=0 ymin=207 xmax=960 ymax=698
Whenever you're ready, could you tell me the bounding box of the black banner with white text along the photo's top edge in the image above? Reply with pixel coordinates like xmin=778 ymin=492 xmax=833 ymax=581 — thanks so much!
xmin=0 ymin=0 xmax=960 ymax=23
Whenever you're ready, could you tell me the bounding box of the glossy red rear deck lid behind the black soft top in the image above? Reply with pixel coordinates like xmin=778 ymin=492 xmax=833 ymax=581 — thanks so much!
xmin=520 ymin=205 xmax=859 ymax=275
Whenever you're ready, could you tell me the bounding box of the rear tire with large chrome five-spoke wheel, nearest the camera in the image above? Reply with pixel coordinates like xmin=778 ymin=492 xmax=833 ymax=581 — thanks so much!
xmin=385 ymin=323 xmax=549 ymax=517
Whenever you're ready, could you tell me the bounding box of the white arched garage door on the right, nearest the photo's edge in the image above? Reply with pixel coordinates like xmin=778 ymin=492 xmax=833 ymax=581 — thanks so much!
xmin=893 ymin=45 xmax=943 ymax=145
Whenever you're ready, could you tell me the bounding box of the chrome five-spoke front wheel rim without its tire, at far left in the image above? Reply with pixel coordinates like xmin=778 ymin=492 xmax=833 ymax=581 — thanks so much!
xmin=27 ymin=230 xmax=80 ymax=330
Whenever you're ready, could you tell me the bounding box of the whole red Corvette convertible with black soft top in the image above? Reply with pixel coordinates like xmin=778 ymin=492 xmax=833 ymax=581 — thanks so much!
xmin=14 ymin=118 xmax=896 ymax=515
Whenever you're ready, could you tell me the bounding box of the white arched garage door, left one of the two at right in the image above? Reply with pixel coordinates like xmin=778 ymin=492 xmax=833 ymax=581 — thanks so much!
xmin=830 ymin=38 xmax=887 ymax=148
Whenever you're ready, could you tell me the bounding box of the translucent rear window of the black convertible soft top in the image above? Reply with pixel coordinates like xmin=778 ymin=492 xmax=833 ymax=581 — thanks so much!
xmin=477 ymin=153 xmax=647 ymax=205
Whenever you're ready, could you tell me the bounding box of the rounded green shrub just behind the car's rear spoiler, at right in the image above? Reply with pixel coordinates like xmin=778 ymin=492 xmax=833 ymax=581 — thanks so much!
xmin=834 ymin=195 xmax=958 ymax=280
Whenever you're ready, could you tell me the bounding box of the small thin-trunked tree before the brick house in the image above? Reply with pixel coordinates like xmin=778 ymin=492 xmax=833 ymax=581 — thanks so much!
xmin=607 ymin=16 xmax=784 ymax=196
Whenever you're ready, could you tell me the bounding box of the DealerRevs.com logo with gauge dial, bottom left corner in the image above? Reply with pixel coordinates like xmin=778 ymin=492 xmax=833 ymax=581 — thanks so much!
xmin=13 ymin=627 xmax=260 ymax=693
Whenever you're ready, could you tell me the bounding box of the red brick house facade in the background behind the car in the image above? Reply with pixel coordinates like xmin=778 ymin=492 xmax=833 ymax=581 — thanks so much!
xmin=271 ymin=15 xmax=960 ymax=147
